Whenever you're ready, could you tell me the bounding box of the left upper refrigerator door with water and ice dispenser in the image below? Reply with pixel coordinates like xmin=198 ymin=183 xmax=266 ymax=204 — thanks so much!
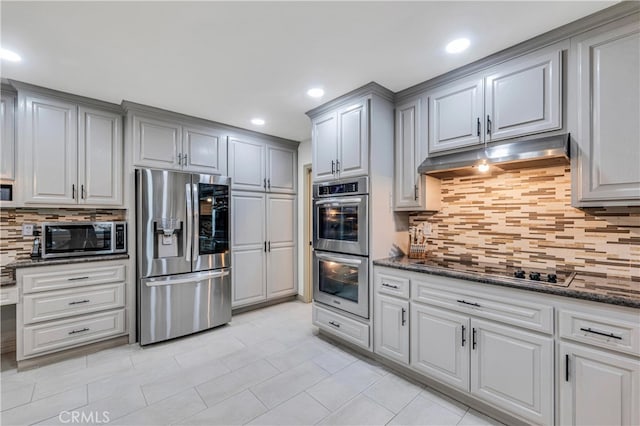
xmin=136 ymin=169 xmax=193 ymax=277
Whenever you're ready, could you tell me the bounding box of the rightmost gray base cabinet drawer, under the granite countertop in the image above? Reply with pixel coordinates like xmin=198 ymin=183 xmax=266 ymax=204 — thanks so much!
xmin=559 ymin=311 xmax=640 ymax=355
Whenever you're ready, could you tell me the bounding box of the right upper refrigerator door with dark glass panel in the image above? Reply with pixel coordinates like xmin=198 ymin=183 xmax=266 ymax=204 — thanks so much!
xmin=192 ymin=175 xmax=231 ymax=271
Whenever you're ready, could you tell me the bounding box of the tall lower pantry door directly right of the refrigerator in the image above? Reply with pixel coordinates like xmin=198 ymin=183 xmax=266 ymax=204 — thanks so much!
xmin=231 ymin=192 xmax=267 ymax=306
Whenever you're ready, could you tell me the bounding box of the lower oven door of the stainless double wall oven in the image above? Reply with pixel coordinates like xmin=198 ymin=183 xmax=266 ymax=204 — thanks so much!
xmin=313 ymin=251 xmax=369 ymax=318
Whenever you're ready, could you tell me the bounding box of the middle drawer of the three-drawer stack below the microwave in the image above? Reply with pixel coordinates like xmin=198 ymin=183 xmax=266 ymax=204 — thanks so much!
xmin=22 ymin=282 xmax=124 ymax=324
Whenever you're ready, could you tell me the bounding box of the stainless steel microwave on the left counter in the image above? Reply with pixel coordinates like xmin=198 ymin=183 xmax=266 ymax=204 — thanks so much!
xmin=42 ymin=222 xmax=127 ymax=259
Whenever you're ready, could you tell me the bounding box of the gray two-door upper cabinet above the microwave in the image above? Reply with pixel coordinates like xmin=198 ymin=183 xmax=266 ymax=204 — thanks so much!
xmin=18 ymin=91 xmax=123 ymax=206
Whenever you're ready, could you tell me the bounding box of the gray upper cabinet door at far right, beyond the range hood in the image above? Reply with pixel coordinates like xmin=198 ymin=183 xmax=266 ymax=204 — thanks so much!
xmin=574 ymin=21 xmax=640 ymax=206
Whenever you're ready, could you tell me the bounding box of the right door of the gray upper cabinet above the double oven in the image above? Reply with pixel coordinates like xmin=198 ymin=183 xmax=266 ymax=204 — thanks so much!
xmin=336 ymin=99 xmax=369 ymax=179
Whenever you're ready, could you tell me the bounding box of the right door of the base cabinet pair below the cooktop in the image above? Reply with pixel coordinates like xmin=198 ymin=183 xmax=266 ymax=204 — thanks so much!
xmin=471 ymin=319 xmax=554 ymax=424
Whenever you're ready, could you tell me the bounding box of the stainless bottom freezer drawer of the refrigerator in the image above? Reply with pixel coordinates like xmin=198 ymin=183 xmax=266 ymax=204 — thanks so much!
xmin=138 ymin=268 xmax=231 ymax=345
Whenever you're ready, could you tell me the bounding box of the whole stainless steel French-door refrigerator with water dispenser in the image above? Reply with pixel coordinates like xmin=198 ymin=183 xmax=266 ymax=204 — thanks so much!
xmin=136 ymin=169 xmax=231 ymax=345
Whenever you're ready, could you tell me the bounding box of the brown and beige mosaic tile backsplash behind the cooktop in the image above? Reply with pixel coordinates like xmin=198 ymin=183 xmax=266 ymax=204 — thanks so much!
xmin=409 ymin=166 xmax=640 ymax=280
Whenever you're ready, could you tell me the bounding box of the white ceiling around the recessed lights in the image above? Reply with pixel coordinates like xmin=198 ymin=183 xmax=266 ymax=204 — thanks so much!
xmin=0 ymin=0 xmax=616 ymax=140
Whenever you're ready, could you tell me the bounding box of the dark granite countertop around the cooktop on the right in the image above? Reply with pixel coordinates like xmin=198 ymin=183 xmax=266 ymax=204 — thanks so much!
xmin=373 ymin=256 xmax=640 ymax=308
